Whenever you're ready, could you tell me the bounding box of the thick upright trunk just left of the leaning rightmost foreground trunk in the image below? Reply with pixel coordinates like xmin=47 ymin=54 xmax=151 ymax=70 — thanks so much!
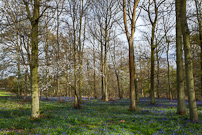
xmin=175 ymin=0 xmax=187 ymax=115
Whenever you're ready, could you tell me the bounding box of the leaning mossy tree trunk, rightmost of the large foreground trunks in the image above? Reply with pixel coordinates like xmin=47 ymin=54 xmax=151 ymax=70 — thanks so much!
xmin=180 ymin=0 xmax=199 ymax=122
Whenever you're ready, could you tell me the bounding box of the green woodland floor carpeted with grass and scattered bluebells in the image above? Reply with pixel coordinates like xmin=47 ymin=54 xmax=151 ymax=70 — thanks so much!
xmin=0 ymin=98 xmax=202 ymax=135
